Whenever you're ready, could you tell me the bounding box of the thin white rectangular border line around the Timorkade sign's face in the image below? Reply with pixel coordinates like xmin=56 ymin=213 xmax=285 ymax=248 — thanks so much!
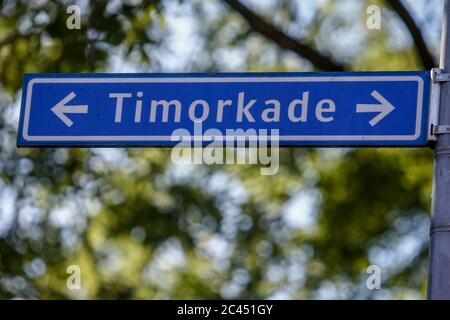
xmin=22 ymin=76 xmax=424 ymax=142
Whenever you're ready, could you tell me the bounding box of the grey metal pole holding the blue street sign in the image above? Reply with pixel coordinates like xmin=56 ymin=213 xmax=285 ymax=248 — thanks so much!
xmin=428 ymin=0 xmax=450 ymax=300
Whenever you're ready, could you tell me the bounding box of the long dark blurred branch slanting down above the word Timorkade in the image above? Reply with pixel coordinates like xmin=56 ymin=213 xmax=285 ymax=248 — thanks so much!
xmin=223 ymin=0 xmax=347 ymax=71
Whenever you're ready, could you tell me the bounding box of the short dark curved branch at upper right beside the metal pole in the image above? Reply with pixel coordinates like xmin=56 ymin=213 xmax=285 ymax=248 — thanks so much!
xmin=386 ymin=0 xmax=436 ymax=69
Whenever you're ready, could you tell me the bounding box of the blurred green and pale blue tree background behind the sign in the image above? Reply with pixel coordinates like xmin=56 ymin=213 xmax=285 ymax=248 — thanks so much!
xmin=0 ymin=0 xmax=443 ymax=299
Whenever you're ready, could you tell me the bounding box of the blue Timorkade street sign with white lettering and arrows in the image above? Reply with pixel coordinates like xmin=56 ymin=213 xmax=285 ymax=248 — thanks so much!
xmin=18 ymin=71 xmax=430 ymax=147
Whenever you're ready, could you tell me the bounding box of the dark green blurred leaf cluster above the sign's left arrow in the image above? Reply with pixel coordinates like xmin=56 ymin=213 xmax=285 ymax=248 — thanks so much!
xmin=0 ymin=0 xmax=161 ymax=92
